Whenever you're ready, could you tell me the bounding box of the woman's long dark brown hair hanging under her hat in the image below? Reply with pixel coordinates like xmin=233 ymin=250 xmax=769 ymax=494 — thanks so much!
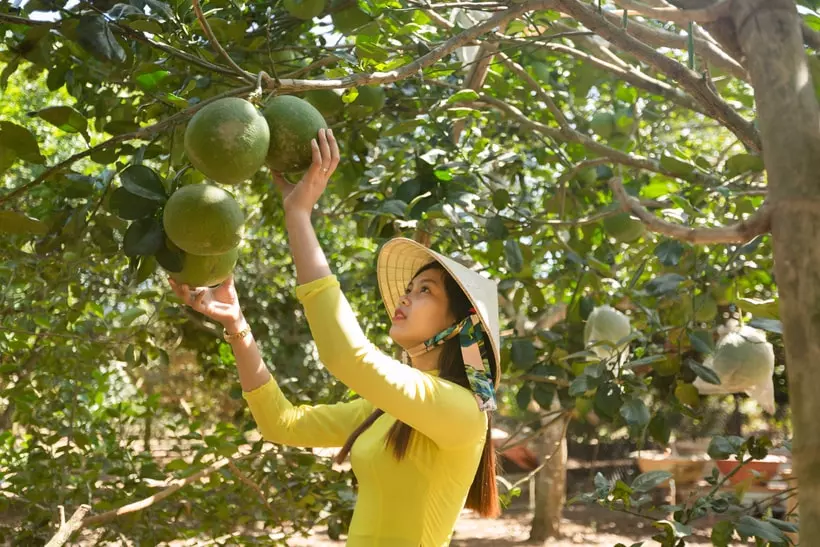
xmin=336 ymin=262 xmax=501 ymax=517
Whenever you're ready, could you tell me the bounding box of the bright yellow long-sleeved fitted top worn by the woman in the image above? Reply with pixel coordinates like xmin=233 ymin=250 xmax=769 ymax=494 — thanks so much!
xmin=244 ymin=276 xmax=487 ymax=547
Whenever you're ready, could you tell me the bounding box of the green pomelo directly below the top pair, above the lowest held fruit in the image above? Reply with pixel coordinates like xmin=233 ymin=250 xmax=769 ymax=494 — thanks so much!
xmin=162 ymin=184 xmax=245 ymax=256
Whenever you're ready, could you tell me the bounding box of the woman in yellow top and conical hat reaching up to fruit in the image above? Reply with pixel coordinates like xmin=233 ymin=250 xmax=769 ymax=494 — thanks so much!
xmin=171 ymin=130 xmax=499 ymax=547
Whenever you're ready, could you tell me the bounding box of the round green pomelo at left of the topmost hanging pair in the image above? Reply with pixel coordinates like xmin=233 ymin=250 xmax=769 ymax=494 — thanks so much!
xmin=184 ymin=97 xmax=270 ymax=184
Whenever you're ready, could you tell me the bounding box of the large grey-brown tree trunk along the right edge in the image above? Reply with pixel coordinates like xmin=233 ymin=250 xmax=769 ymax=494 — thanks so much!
xmin=732 ymin=0 xmax=820 ymax=546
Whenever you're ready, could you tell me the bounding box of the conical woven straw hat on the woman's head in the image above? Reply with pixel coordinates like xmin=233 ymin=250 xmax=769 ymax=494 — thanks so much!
xmin=376 ymin=237 xmax=501 ymax=387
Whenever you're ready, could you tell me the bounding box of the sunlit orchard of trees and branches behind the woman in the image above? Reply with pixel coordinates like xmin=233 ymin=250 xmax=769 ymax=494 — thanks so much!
xmin=0 ymin=0 xmax=820 ymax=546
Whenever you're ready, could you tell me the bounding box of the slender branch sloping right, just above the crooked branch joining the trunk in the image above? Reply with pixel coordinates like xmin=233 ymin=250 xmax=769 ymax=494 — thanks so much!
xmin=479 ymin=95 xmax=719 ymax=186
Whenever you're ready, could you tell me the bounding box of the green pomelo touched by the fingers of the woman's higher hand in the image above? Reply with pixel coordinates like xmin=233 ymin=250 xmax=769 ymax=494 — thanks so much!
xmin=263 ymin=95 xmax=327 ymax=173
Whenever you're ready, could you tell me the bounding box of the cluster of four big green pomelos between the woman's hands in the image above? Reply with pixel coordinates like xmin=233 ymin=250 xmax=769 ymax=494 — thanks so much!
xmin=162 ymin=95 xmax=327 ymax=286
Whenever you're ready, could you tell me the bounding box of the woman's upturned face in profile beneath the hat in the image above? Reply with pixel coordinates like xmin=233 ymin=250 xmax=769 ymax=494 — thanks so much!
xmin=390 ymin=269 xmax=456 ymax=349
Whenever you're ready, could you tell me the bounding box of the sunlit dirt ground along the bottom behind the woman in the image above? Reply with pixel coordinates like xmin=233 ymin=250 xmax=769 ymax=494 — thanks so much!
xmin=288 ymin=503 xmax=742 ymax=547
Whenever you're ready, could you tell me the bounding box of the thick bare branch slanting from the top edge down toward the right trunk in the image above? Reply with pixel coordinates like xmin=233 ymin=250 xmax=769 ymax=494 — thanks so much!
xmin=559 ymin=0 xmax=761 ymax=152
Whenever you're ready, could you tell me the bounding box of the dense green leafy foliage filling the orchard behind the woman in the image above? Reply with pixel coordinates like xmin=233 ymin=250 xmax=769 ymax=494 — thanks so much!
xmin=0 ymin=0 xmax=804 ymax=545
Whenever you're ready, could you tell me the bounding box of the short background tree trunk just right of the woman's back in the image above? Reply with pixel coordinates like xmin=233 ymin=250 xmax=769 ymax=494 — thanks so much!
xmin=530 ymin=397 xmax=567 ymax=542
